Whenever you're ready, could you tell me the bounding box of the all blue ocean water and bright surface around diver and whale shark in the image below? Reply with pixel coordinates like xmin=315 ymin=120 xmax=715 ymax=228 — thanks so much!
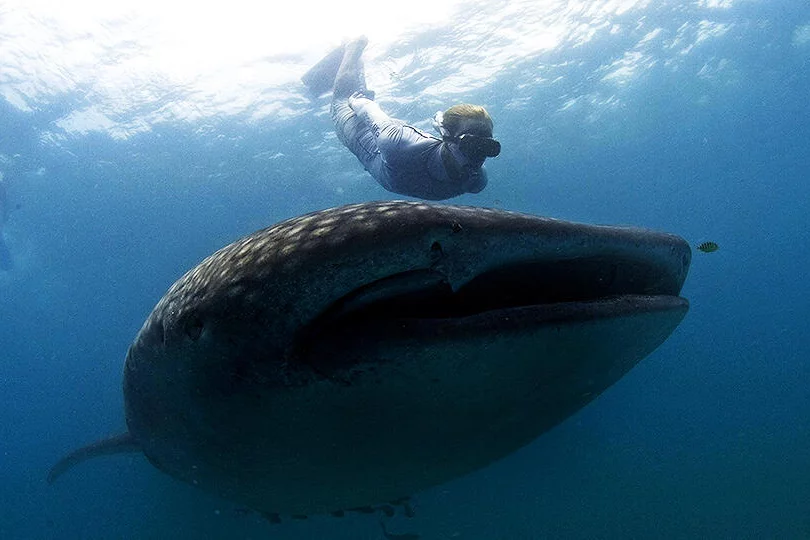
xmin=0 ymin=0 xmax=810 ymax=540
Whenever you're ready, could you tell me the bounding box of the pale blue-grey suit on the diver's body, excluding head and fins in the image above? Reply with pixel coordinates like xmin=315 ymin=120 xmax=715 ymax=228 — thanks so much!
xmin=331 ymin=41 xmax=487 ymax=201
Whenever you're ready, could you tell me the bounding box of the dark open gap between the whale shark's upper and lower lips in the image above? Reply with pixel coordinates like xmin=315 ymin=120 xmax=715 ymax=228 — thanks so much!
xmin=314 ymin=253 xmax=682 ymax=327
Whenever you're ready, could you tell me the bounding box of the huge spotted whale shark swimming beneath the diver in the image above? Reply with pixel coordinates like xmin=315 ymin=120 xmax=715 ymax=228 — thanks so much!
xmin=48 ymin=201 xmax=691 ymax=516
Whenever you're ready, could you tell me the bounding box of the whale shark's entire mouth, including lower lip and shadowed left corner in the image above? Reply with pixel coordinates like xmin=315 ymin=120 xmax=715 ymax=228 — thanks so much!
xmin=289 ymin=256 xmax=688 ymax=377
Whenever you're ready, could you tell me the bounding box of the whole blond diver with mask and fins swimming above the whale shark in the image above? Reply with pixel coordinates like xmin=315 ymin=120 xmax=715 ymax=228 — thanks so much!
xmin=301 ymin=37 xmax=501 ymax=201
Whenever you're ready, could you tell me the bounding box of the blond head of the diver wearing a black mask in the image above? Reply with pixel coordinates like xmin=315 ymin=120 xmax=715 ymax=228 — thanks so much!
xmin=433 ymin=103 xmax=501 ymax=163
